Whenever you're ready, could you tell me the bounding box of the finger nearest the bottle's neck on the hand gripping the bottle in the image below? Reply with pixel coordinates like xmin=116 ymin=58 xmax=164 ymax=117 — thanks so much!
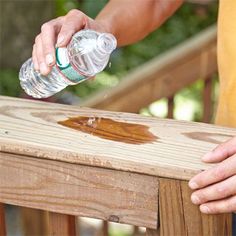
xmin=57 ymin=9 xmax=87 ymax=47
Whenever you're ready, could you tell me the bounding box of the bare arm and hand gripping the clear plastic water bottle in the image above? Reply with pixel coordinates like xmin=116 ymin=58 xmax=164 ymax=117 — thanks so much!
xmin=32 ymin=0 xmax=183 ymax=75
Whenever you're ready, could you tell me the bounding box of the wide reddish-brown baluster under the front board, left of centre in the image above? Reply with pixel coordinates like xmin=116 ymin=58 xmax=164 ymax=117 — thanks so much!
xmin=48 ymin=212 xmax=76 ymax=236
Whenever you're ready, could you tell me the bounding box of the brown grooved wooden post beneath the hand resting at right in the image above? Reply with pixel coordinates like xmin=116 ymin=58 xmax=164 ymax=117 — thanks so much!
xmin=159 ymin=178 xmax=232 ymax=236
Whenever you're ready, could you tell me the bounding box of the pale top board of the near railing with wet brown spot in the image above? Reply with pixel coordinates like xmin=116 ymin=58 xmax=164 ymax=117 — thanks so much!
xmin=0 ymin=97 xmax=236 ymax=180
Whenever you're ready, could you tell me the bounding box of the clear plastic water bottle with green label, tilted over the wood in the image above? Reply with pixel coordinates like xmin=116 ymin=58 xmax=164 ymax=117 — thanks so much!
xmin=19 ymin=30 xmax=116 ymax=98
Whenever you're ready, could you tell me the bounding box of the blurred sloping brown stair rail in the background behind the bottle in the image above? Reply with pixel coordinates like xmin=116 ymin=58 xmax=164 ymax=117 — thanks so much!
xmin=80 ymin=26 xmax=218 ymax=113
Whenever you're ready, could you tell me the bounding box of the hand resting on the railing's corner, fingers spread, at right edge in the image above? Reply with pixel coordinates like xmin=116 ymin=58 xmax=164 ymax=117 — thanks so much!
xmin=189 ymin=137 xmax=236 ymax=214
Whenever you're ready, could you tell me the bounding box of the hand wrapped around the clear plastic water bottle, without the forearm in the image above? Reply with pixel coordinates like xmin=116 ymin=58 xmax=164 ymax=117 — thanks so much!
xmin=32 ymin=9 xmax=108 ymax=75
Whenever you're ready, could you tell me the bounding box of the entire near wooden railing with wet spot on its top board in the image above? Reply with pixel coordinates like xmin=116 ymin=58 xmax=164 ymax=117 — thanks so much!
xmin=0 ymin=97 xmax=236 ymax=236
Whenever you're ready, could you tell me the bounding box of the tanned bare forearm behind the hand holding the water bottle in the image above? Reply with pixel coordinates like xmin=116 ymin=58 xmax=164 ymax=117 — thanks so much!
xmin=96 ymin=0 xmax=183 ymax=46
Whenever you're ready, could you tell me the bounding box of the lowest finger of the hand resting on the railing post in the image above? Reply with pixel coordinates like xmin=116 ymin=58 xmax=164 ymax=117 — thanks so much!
xmin=200 ymin=196 xmax=236 ymax=214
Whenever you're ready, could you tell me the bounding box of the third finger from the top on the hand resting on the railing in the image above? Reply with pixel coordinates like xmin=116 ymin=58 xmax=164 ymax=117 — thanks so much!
xmin=191 ymin=175 xmax=236 ymax=205
